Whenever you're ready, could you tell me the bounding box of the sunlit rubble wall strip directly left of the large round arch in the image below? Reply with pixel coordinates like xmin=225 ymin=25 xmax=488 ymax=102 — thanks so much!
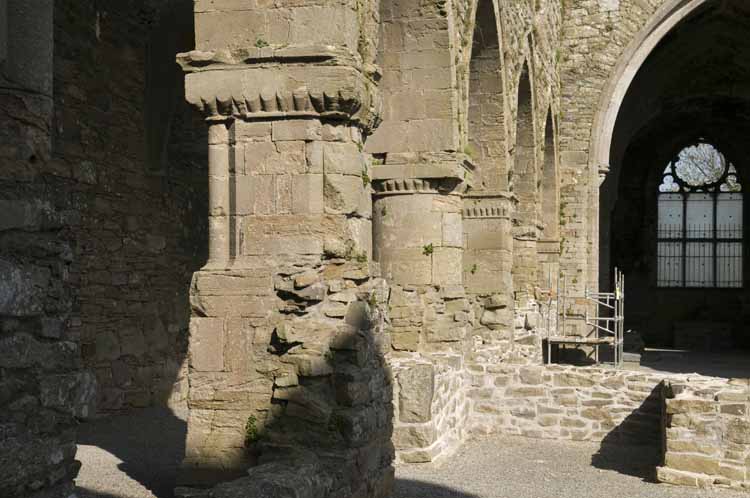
xmin=557 ymin=0 xmax=665 ymax=294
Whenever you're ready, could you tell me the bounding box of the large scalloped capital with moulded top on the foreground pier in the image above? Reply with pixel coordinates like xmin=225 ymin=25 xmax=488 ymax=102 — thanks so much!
xmin=178 ymin=47 xmax=381 ymax=130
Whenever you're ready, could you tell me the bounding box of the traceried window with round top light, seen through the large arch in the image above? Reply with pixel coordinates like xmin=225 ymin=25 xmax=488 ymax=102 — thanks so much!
xmin=657 ymin=142 xmax=743 ymax=288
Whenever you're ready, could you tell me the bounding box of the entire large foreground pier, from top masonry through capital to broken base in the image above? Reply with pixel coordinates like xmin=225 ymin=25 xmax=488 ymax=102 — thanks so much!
xmin=178 ymin=2 xmax=400 ymax=497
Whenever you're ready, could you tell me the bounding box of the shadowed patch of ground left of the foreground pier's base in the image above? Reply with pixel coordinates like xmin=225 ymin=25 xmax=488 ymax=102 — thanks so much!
xmin=78 ymin=408 xmax=187 ymax=498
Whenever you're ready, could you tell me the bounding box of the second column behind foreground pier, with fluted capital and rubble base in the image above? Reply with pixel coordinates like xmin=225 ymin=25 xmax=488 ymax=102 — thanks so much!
xmin=373 ymin=153 xmax=472 ymax=462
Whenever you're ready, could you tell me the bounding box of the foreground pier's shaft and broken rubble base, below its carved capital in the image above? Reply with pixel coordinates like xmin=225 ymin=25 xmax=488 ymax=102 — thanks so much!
xmin=178 ymin=119 xmax=393 ymax=497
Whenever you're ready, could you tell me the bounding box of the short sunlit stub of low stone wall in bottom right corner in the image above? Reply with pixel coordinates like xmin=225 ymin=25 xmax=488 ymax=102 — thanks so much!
xmin=657 ymin=378 xmax=750 ymax=491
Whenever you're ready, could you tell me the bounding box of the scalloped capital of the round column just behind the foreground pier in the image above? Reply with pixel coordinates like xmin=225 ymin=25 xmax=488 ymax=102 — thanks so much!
xmin=372 ymin=152 xmax=474 ymax=195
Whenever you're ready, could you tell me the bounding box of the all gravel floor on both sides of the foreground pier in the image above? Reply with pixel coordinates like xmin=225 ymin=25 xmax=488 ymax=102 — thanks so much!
xmin=77 ymin=409 xmax=750 ymax=498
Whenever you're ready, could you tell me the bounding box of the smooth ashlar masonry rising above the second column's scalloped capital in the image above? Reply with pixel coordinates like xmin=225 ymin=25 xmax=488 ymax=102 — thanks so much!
xmin=365 ymin=0 xmax=460 ymax=154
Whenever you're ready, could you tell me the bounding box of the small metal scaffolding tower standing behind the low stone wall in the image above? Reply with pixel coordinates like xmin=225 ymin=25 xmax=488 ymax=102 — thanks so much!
xmin=547 ymin=268 xmax=625 ymax=367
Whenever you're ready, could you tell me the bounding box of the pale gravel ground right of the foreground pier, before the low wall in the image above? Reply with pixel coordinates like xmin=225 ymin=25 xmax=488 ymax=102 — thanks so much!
xmin=393 ymin=436 xmax=748 ymax=498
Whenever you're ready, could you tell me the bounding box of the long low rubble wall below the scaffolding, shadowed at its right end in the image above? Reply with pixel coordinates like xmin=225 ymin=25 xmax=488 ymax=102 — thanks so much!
xmin=468 ymin=364 xmax=662 ymax=443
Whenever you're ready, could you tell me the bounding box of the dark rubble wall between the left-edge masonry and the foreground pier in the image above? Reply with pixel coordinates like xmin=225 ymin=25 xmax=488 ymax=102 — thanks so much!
xmin=57 ymin=1 xmax=207 ymax=412
